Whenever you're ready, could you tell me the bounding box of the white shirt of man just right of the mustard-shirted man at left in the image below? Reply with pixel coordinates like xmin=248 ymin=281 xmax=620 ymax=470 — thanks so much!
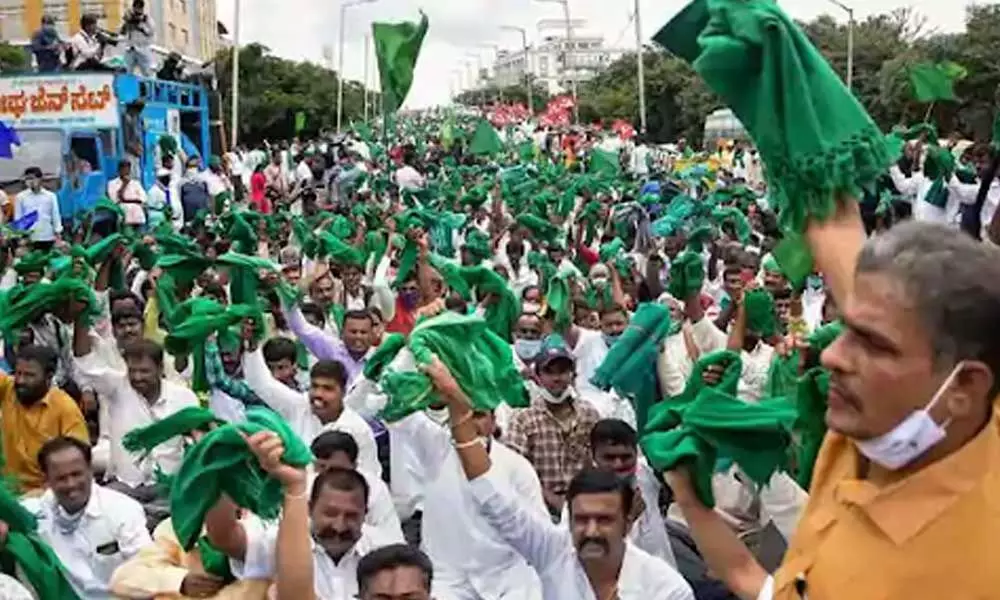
xmin=76 ymin=352 xmax=199 ymax=487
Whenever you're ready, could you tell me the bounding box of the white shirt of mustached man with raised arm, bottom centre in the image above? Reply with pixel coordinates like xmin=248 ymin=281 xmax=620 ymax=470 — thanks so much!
xmin=470 ymin=468 xmax=694 ymax=600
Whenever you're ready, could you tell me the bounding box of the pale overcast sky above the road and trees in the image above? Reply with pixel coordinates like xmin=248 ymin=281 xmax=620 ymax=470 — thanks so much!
xmin=217 ymin=0 xmax=965 ymax=108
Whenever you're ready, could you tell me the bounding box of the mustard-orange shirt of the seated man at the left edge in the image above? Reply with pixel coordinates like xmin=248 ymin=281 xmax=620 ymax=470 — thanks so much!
xmin=0 ymin=374 xmax=90 ymax=492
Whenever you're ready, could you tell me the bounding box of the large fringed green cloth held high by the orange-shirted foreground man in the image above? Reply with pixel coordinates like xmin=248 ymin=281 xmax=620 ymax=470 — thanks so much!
xmin=654 ymin=0 xmax=892 ymax=237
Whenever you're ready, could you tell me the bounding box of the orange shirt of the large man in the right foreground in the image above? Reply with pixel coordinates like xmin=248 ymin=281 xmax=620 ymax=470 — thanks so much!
xmin=774 ymin=408 xmax=1000 ymax=600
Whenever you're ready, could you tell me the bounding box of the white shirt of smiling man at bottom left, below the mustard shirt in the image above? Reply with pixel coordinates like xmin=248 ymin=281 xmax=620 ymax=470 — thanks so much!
xmin=23 ymin=483 xmax=153 ymax=600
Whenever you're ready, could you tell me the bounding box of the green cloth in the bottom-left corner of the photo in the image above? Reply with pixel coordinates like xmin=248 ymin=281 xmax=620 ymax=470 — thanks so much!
xmin=0 ymin=485 xmax=79 ymax=600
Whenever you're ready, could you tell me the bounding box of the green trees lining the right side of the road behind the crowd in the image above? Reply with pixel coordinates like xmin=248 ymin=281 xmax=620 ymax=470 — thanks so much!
xmin=457 ymin=4 xmax=1000 ymax=143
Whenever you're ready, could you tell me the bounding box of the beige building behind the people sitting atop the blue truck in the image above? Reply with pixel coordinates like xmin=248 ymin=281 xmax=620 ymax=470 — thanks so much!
xmin=0 ymin=0 xmax=220 ymax=64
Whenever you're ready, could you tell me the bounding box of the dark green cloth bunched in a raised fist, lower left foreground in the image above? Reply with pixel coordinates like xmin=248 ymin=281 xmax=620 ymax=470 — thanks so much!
xmin=124 ymin=407 xmax=312 ymax=551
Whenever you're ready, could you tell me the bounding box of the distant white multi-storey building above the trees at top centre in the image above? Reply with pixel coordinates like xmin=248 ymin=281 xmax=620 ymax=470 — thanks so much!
xmin=490 ymin=20 xmax=628 ymax=94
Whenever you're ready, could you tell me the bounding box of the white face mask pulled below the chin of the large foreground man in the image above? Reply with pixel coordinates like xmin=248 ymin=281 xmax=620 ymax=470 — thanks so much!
xmin=854 ymin=363 xmax=963 ymax=471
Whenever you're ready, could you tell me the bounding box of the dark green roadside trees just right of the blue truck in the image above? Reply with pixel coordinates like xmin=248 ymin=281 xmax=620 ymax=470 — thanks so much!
xmin=216 ymin=44 xmax=379 ymax=143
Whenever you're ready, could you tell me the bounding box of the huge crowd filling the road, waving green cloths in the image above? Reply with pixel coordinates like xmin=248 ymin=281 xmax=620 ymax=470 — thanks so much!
xmin=0 ymin=2 xmax=1000 ymax=600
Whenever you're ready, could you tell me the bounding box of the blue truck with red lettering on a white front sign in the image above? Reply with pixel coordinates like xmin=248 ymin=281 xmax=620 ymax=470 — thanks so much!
xmin=0 ymin=72 xmax=211 ymax=221
